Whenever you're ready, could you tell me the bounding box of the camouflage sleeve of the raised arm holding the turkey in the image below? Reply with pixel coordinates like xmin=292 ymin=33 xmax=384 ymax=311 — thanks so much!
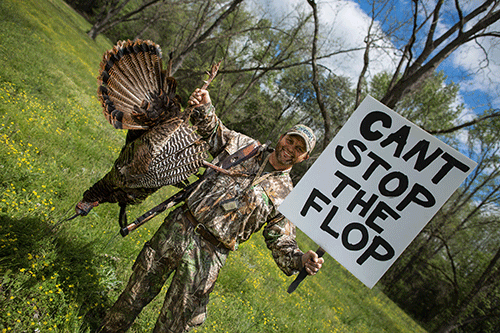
xmin=191 ymin=103 xmax=239 ymax=156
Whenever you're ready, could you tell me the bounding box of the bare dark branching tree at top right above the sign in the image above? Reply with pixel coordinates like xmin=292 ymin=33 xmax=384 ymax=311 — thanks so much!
xmin=378 ymin=0 xmax=500 ymax=128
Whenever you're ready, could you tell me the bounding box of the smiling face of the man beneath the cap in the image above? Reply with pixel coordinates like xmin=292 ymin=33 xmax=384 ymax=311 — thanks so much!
xmin=275 ymin=134 xmax=309 ymax=168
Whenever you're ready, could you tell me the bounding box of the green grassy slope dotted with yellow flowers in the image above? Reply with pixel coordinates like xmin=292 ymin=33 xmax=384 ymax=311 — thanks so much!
xmin=0 ymin=0 xmax=424 ymax=332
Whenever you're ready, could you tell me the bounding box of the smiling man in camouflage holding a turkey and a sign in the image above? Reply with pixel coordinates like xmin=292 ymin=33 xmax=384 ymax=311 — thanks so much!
xmin=100 ymin=89 xmax=324 ymax=332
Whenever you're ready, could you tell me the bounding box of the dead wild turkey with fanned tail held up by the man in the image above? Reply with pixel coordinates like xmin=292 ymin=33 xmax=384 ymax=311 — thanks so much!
xmin=75 ymin=40 xmax=218 ymax=225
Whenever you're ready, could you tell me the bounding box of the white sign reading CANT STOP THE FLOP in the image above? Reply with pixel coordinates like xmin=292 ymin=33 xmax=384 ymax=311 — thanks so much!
xmin=279 ymin=97 xmax=476 ymax=288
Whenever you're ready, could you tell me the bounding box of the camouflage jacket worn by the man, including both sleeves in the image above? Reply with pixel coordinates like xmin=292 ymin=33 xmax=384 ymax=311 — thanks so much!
xmin=186 ymin=104 xmax=303 ymax=275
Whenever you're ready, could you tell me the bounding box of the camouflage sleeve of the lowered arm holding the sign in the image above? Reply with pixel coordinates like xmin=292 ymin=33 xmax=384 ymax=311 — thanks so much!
xmin=263 ymin=214 xmax=304 ymax=276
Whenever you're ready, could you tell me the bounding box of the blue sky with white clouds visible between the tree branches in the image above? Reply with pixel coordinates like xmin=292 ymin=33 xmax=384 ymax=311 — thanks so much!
xmin=251 ymin=0 xmax=500 ymax=117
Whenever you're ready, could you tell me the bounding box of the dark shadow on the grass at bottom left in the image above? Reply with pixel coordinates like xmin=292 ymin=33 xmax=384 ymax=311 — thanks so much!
xmin=0 ymin=214 xmax=120 ymax=331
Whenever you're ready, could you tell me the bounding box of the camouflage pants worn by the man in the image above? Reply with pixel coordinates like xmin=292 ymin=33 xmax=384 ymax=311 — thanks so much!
xmin=100 ymin=208 xmax=229 ymax=332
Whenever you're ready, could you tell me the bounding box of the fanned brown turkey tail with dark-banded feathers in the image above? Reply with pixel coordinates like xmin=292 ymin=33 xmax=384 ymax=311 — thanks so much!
xmin=97 ymin=40 xmax=180 ymax=130
